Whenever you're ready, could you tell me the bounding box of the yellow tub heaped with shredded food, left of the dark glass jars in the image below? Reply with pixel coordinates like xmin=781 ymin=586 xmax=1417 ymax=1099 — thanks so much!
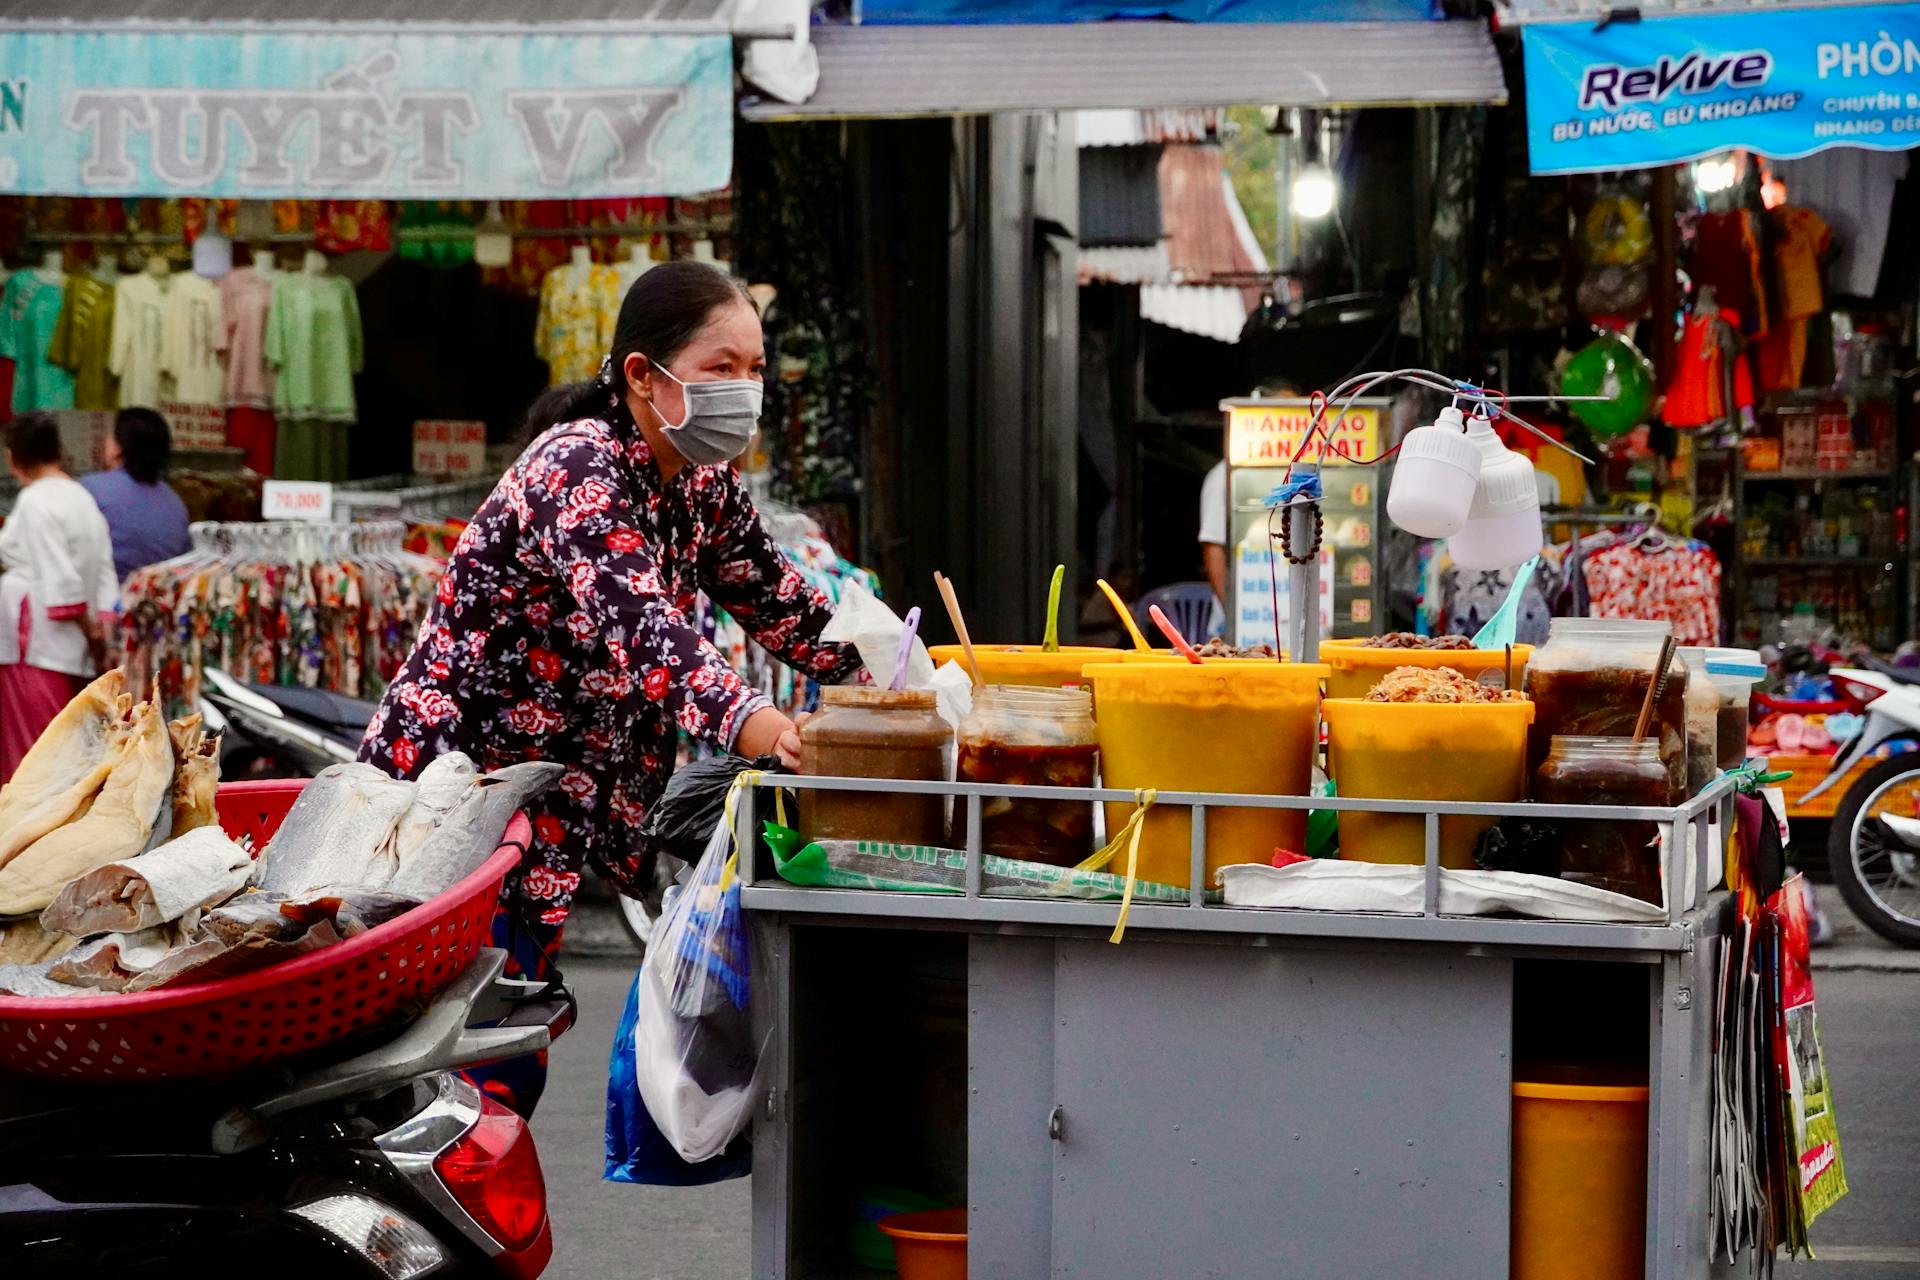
xmin=1323 ymin=699 xmax=1534 ymax=867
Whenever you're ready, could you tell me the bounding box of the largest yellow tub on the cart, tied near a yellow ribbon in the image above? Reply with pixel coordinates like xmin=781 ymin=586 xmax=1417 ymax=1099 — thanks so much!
xmin=1087 ymin=662 xmax=1327 ymax=885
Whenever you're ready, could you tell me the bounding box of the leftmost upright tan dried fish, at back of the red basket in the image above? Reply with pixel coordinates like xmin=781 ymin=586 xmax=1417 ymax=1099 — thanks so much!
xmin=0 ymin=670 xmax=125 ymax=867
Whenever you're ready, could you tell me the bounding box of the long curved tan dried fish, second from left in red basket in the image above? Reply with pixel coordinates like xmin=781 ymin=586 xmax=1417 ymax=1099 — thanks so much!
xmin=0 ymin=702 xmax=173 ymax=915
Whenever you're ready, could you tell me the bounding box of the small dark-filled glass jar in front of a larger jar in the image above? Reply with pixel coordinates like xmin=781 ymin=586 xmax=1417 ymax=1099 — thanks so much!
xmin=1534 ymin=735 xmax=1668 ymax=902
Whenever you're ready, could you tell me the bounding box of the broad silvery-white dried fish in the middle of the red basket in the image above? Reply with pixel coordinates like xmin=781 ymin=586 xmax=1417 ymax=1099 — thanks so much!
xmin=253 ymin=764 xmax=413 ymax=896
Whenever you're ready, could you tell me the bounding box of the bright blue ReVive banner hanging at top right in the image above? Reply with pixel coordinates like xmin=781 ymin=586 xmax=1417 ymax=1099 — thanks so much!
xmin=1523 ymin=4 xmax=1920 ymax=173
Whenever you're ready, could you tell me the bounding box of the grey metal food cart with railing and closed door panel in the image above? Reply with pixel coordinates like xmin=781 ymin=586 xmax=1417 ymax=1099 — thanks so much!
xmin=739 ymin=779 xmax=1734 ymax=1280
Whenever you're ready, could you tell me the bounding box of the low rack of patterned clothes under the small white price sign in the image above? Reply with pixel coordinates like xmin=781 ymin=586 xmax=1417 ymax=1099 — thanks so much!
xmin=121 ymin=524 xmax=440 ymax=714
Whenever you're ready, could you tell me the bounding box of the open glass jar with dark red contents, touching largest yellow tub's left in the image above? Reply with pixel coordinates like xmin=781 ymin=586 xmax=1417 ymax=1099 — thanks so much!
xmin=956 ymin=685 xmax=1100 ymax=867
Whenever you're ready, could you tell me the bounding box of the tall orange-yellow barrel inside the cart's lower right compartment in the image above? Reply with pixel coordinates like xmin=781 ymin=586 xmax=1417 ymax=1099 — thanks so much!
xmin=1507 ymin=1080 xmax=1647 ymax=1280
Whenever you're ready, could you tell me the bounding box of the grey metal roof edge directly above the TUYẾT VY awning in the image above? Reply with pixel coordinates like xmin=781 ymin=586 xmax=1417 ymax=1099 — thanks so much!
xmin=0 ymin=0 xmax=739 ymax=35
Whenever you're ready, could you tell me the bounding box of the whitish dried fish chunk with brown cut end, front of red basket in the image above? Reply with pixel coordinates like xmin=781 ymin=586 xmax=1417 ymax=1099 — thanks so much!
xmin=40 ymin=827 xmax=253 ymax=936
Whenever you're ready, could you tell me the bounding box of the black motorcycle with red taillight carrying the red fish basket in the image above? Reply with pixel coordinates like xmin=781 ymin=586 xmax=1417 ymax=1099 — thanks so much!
xmin=0 ymin=950 xmax=576 ymax=1280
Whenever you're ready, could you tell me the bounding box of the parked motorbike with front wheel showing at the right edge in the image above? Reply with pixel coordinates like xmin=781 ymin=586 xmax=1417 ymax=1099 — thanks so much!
xmin=1803 ymin=654 xmax=1920 ymax=948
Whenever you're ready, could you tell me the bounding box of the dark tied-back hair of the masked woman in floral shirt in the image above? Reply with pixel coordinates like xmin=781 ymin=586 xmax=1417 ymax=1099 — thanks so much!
xmin=526 ymin=259 xmax=753 ymax=441
